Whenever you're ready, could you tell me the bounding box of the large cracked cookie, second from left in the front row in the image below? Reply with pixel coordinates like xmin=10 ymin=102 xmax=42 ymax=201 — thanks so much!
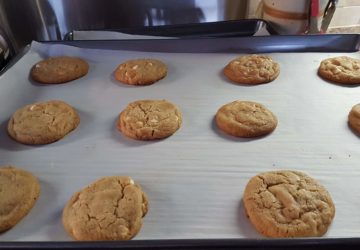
xmin=62 ymin=176 xmax=148 ymax=241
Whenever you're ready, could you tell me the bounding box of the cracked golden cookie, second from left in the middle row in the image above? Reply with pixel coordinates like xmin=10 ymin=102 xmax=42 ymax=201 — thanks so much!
xmin=116 ymin=100 xmax=182 ymax=140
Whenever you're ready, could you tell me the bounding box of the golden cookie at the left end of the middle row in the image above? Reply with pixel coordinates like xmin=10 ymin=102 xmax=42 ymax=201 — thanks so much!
xmin=7 ymin=100 xmax=80 ymax=145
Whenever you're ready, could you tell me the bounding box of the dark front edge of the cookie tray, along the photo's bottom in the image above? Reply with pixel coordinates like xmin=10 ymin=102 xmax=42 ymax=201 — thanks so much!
xmin=0 ymin=238 xmax=360 ymax=250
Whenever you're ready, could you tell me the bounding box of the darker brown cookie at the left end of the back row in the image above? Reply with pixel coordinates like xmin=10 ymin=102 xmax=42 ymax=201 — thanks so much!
xmin=30 ymin=56 xmax=89 ymax=84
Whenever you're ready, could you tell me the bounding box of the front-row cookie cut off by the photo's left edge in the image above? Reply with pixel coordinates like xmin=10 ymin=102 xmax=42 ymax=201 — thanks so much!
xmin=0 ymin=166 xmax=40 ymax=233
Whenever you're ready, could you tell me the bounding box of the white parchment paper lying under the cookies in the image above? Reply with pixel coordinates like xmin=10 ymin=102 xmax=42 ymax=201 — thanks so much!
xmin=0 ymin=42 xmax=360 ymax=241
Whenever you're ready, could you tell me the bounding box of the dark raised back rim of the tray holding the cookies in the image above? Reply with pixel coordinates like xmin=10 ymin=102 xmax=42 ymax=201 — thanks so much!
xmin=47 ymin=34 xmax=360 ymax=53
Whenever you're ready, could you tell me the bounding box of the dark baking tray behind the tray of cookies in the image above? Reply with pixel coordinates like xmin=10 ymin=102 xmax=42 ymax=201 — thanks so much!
xmin=64 ymin=19 xmax=277 ymax=40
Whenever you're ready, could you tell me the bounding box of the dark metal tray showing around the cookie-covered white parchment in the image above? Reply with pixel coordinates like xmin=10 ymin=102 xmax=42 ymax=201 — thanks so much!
xmin=0 ymin=34 xmax=360 ymax=250
